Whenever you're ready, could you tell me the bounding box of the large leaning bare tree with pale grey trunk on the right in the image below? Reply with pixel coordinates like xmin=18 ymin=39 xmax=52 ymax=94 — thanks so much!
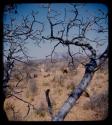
xmin=43 ymin=4 xmax=108 ymax=121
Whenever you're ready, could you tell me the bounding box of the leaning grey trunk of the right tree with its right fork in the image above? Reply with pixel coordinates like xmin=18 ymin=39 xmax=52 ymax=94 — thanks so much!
xmin=52 ymin=47 xmax=108 ymax=121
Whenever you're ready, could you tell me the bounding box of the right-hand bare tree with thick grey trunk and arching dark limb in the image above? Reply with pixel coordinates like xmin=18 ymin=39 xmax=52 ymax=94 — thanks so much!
xmin=42 ymin=4 xmax=108 ymax=121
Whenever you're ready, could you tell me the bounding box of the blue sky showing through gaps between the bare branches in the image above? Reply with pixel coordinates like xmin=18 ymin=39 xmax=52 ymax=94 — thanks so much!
xmin=4 ymin=3 xmax=108 ymax=59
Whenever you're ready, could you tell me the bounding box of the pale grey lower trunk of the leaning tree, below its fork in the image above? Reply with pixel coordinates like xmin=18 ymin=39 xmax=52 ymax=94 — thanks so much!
xmin=53 ymin=69 xmax=94 ymax=121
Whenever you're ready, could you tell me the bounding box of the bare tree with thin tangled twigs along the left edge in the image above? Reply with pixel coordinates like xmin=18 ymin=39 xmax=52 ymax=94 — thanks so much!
xmin=2 ymin=4 xmax=44 ymax=119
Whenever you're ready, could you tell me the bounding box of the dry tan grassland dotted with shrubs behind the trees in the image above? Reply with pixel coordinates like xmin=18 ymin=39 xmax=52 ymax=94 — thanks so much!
xmin=4 ymin=59 xmax=108 ymax=121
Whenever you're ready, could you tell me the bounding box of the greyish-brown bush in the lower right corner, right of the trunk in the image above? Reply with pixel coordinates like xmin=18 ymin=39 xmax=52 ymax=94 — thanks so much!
xmin=83 ymin=91 xmax=108 ymax=119
